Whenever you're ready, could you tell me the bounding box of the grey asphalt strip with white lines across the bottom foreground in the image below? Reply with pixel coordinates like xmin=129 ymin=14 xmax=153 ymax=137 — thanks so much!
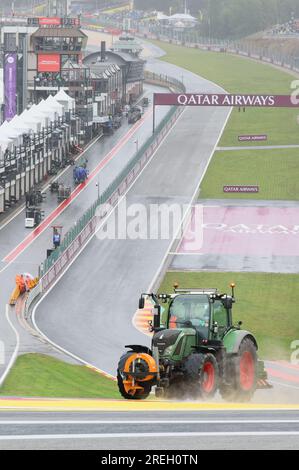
xmin=0 ymin=411 xmax=299 ymax=451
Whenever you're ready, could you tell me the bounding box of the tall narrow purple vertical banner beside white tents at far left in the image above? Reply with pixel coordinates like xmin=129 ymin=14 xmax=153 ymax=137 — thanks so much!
xmin=3 ymin=52 xmax=17 ymax=121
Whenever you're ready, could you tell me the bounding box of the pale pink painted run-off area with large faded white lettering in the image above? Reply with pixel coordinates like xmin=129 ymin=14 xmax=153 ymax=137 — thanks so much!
xmin=178 ymin=207 xmax=299 ymax=256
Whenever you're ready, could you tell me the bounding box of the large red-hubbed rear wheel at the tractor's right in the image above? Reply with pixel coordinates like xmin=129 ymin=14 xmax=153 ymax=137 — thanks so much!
xmin=220 ymin=338 xmax=257 ymax=402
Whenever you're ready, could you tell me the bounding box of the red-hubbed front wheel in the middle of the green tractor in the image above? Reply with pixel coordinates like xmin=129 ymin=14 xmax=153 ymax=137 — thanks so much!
xmin=185 ymin=353 xmax=219 ymax=400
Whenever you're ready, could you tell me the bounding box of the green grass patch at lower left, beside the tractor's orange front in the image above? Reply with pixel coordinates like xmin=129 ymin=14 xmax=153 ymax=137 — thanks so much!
xmin=0 ymin=354 xmax=121 ymax=398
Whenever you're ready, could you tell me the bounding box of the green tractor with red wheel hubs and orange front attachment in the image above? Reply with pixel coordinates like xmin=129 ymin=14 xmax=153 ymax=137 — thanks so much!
xmin=117 ymin=284 xmax=271 ymax=402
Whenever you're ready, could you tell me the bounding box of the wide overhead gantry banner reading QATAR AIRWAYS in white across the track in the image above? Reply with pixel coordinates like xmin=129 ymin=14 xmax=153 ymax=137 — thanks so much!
xmin=154 ymin=93 xmax=299 ymax=108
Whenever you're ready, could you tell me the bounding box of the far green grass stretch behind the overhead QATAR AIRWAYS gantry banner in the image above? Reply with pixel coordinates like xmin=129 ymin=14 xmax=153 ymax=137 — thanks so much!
xmin=154 ymin=41 xmax=299 ymax=146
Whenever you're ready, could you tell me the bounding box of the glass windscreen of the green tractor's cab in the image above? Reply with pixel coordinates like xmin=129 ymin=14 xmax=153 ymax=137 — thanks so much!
xmin=169 ymin=294 xmax=210 ymax=338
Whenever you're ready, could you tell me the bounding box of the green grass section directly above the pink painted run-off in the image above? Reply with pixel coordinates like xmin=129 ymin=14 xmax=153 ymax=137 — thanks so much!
xmin=200 ymin=149 xmax=299 ymax=200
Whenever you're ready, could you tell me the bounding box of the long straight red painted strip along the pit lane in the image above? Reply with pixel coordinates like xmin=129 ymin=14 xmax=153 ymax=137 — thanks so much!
xmin=3 ymin=110 xmax=151 ymax=263
